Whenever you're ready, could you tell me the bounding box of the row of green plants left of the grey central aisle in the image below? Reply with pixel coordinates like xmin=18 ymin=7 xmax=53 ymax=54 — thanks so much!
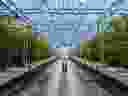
xmin=0 ymin=16 xmax=48 ymax=61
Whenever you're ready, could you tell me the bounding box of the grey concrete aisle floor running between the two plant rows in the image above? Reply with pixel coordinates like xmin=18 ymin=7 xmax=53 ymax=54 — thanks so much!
xmin=18 ymin=60 xmax=111 ymax=96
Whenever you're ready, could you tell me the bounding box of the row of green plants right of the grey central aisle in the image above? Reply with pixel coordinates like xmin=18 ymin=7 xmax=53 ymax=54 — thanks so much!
xmin=80 ymin=16 xmax=128 ymax=65
